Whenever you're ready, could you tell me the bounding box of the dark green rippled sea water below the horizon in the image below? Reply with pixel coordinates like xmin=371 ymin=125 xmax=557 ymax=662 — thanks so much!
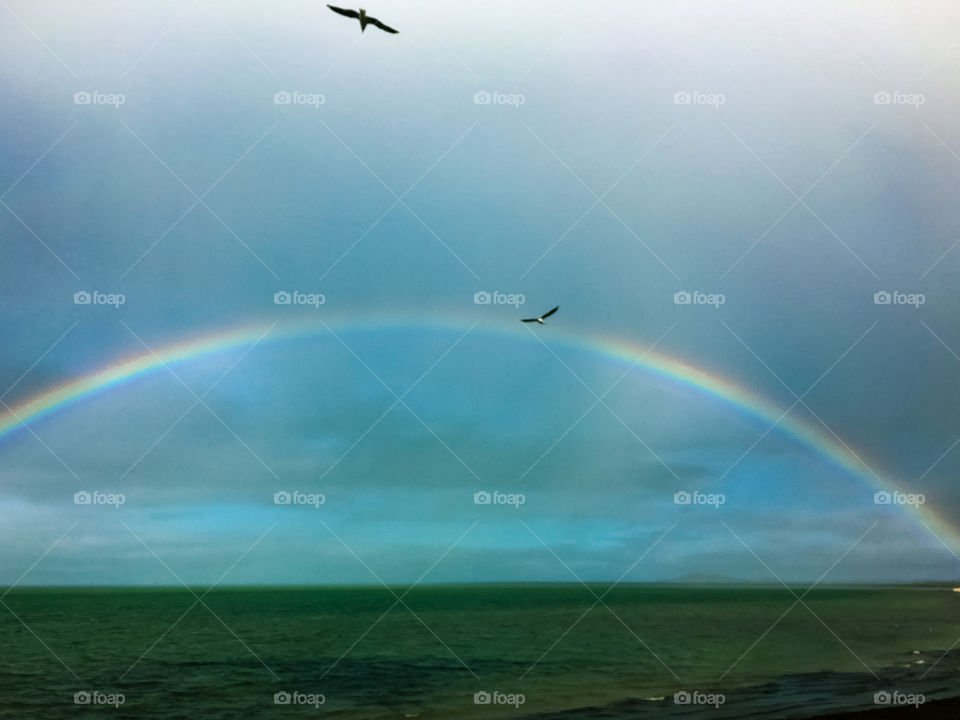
xmin=0 ymin=585 xmax=960 ymax=719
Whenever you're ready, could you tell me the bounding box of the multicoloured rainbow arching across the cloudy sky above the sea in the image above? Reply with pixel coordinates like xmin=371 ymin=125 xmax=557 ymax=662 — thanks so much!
xmin=0 ymin=318 xmax=960 ymax=548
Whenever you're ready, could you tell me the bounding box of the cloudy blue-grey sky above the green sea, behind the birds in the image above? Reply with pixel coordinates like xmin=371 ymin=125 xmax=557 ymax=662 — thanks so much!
xmin=0 ymin=0 xmax=960 ymax=586
